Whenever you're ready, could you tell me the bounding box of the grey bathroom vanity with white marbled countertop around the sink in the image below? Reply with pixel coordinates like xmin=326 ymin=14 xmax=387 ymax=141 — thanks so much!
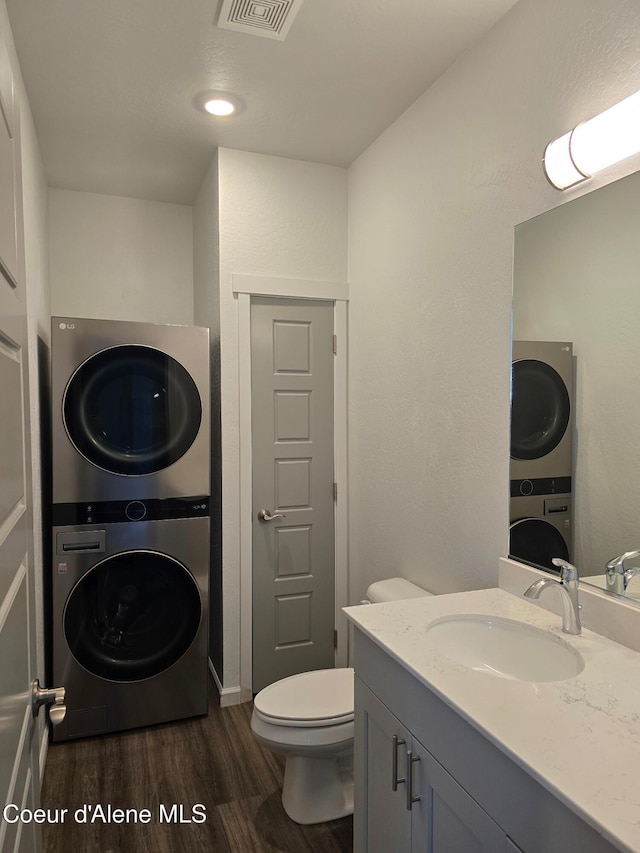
xmin=345 ymin=589 xmax=640 ymax=853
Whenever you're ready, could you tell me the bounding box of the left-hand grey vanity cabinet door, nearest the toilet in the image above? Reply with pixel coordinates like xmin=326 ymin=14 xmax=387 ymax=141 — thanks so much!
xmin=354 ymin=678 xmax=412 ymax=853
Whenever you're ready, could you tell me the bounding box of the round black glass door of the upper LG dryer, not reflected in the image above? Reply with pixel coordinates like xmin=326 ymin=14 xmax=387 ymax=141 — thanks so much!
xmin=63 ymin=345 xmax=202 ymax=474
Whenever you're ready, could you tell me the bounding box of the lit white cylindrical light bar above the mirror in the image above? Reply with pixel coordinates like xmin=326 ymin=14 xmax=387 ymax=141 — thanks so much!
xmin=543 ymin=92 xmax=640 ymax=190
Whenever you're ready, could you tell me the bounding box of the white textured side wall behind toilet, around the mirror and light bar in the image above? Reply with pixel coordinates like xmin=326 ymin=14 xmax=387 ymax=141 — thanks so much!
xmin=349 ymin=0 xmax=640 ymax=601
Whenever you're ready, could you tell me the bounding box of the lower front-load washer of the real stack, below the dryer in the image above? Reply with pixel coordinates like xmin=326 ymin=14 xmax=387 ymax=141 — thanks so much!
xmin=51 ymin=510 xmax=209 ymax=741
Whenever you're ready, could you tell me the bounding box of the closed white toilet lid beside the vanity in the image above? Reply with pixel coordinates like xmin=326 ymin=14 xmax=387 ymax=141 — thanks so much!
xmin=253 ymin=668 xmax=353 ymax=726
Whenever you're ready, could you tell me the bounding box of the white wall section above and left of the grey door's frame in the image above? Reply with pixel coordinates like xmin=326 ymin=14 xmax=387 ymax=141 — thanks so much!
xmin=218 ymin=149 xmax=347 ymax=688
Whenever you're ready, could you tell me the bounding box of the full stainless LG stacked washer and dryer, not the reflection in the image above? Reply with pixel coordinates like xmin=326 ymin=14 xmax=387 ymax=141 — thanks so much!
xmin=50 ymin=317 xmax=210 ymax=740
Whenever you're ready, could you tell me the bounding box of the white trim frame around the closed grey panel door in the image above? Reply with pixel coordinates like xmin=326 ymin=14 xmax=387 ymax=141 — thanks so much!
xmin=232 ymin=273 xmax=349 ymax=698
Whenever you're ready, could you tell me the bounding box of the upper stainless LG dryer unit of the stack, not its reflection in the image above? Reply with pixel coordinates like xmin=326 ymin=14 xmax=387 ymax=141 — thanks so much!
xmin=51 ymin=317 xmax=210 ymax=506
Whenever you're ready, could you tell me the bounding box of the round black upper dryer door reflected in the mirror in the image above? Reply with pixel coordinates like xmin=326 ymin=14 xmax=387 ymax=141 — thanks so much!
xmin=511 ymin=359 xmax=571 ymax=459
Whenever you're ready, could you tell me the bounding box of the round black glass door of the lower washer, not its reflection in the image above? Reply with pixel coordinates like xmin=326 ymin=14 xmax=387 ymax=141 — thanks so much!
xmin=63 ymin=551 xmax=202 ymax=681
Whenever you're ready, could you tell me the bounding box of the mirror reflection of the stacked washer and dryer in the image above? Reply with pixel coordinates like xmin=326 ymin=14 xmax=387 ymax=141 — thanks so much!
xmin=509 ymin=341 xmax=574 ymax=572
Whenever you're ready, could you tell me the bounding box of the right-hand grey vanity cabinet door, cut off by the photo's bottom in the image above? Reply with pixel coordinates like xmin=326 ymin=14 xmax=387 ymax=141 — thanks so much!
xmin=411 ymin=738 xmax=516 ymax=853
